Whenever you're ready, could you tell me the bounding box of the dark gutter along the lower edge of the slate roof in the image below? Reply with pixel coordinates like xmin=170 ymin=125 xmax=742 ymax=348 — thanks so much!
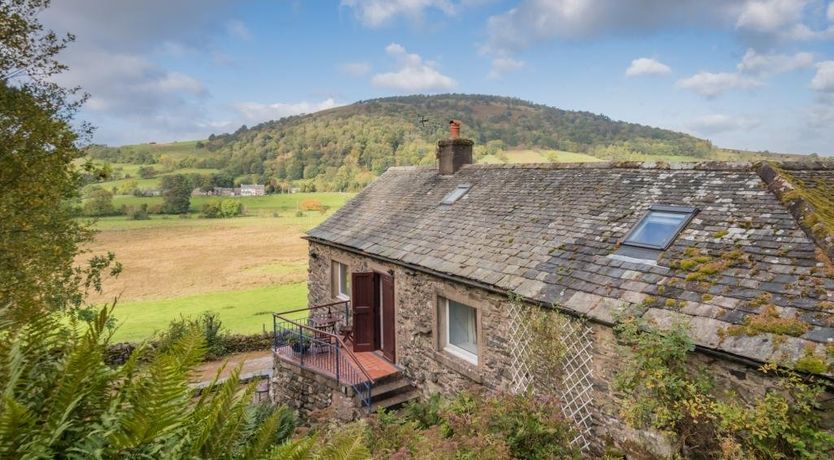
xmin=301 ymin=235 xmax=834 ymax=390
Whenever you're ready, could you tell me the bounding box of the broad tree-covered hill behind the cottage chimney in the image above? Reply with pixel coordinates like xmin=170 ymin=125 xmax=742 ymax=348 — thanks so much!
xmin=90 ymin=94 xmax=788 ymax=191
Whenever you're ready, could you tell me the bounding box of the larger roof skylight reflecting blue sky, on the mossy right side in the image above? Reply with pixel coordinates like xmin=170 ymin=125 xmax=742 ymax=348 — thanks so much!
xmin=623 ymin=205 xmax=698 ymax=251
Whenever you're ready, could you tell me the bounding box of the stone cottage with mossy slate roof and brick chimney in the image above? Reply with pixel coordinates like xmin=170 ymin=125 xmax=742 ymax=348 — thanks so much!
xmin=273 ymin=124 xmax=834 ymax=454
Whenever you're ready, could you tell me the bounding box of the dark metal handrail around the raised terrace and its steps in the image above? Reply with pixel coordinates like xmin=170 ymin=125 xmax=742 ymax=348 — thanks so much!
xmin=272 ymin=300 xmax=374 ymax=409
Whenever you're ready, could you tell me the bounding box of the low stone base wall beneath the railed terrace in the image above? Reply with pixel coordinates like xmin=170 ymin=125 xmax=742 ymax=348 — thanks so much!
xmin=270 ymin=358 xmax=360 ymax=424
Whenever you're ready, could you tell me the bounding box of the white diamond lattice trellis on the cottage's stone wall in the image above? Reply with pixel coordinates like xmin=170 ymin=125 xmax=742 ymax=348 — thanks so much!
xmin=509 ymin=302 xmax=593 ymax=450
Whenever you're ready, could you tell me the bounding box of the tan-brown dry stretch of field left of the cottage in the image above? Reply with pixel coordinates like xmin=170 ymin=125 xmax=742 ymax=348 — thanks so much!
xmin=83 ymin=225 xmax=307 ymax=302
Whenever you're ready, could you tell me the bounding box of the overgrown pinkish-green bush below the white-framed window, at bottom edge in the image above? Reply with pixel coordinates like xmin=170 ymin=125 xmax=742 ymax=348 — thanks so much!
xmin=366 ymin=392 xmax=580 ymax=459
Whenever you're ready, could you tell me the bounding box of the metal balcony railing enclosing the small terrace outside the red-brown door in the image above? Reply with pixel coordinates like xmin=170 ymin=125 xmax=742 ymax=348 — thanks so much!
xmin=272 ymin=300 xmax=374 ymax=410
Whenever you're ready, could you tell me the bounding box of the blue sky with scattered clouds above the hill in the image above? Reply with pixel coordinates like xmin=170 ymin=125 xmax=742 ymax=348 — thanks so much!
xmin=43 ymin=0 xmax=834 ymax=154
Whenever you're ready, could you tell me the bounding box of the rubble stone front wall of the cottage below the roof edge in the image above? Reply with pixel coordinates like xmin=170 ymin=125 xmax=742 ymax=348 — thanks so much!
xmin=309 ymin=242 xmax=824 ymax=458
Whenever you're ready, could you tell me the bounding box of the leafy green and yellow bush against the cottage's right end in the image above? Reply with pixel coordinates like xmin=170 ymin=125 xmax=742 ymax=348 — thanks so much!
xmin=615 ymin=318 xmax=834 ymax=458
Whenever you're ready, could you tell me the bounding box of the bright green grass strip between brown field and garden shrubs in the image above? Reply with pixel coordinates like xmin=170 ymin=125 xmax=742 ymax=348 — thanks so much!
xmin=113 ymin=283 xmax=307 ymax=341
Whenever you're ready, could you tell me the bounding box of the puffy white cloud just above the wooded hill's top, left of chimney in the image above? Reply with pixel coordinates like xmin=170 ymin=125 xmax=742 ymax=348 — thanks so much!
xmin=371 ymin=43 xmax=457 ymax=93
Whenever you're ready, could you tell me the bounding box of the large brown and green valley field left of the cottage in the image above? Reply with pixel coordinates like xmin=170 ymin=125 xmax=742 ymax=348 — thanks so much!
xmin=86 ymin=193 xmax=352 ymax=341
